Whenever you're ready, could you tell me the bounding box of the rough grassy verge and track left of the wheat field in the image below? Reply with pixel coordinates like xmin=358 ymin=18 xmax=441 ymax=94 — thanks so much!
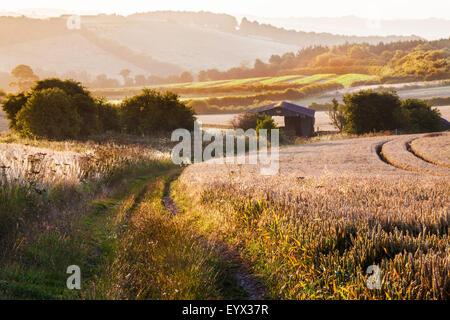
xmin=0 ymin=132 xmax=250 ymax=299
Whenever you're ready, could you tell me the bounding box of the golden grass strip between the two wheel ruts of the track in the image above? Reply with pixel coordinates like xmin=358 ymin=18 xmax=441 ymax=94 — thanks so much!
xmin=86 ymin=171 xmax=244 ymax=300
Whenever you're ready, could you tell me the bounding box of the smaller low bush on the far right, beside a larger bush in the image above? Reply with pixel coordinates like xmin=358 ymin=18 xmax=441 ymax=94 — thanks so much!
xmin=398 ymin=99 xmax=441 ymax=132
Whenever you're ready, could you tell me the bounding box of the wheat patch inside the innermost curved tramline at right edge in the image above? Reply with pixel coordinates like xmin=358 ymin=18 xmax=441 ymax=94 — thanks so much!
xmin=410 ymin=132 xmax=450 ymax=168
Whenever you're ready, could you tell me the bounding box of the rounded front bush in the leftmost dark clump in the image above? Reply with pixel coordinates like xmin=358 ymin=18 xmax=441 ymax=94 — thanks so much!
xmin=16 ymin=88 xmax=82 ymax=139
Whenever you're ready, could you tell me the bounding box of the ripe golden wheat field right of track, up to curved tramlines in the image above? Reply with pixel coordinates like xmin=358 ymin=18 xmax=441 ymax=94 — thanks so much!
xmin=176 ymin=136 xmax=450 ymax=299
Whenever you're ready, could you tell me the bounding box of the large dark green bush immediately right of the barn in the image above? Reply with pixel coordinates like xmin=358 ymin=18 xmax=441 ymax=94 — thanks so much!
xmin=343 ymin=90 xmax=402 ymax=134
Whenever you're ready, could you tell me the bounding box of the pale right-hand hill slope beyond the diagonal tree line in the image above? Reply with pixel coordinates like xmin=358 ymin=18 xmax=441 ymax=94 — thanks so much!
xmin=84 ymin=11 xmax=420 ymax=72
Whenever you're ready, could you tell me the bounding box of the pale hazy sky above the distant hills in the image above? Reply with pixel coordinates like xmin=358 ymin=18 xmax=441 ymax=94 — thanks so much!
xmin=0 ymin=0 xmax=450 ymax=19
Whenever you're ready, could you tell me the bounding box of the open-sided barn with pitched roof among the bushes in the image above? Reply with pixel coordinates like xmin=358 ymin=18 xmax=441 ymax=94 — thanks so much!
xmin=247 ymin=101 xmax=315 ymax=137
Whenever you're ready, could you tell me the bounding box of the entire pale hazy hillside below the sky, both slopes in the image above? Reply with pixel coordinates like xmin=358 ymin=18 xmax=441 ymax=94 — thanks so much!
xmin=0 ymin=12 xmax=426 ymax=81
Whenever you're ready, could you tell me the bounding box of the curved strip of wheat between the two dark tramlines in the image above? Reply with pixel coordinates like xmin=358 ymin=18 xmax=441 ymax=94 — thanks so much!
xmin=379 ymin=135 xmax=450 ymax=176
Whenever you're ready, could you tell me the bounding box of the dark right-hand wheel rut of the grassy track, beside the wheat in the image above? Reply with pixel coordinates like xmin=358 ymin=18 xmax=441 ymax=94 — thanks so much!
xmin=162 ymin=173 xmax=264 ymax=300
